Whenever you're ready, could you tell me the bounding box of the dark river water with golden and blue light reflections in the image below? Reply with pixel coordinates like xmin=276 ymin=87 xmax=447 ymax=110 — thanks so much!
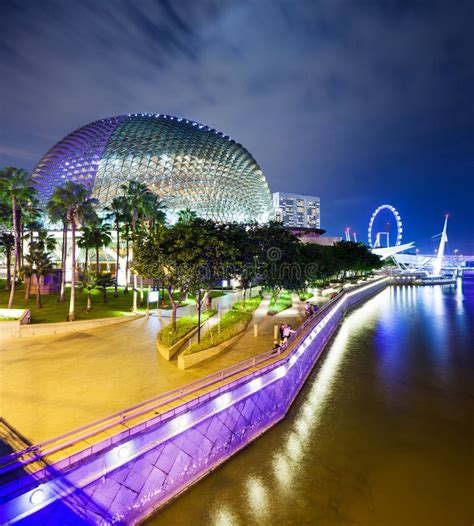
xmin=148 ymin=282 xmax=474 ymax=526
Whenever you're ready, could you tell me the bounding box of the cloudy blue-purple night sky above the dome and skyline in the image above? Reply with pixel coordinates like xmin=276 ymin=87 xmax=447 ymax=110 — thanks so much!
xmin=0 ymin=0 xmax=474 ymax=254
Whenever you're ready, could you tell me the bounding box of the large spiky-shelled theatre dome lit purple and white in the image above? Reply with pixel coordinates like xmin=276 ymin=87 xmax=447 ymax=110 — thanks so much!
xmin=33 ymin=113 xmax=273 ymax=222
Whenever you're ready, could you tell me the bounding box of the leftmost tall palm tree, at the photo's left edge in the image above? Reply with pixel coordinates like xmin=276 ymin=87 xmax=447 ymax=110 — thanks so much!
xmin=0 ymin=166 xmax=35 ymax=309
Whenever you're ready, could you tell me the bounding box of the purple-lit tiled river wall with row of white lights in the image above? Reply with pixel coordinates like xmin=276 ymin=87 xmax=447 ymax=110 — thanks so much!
xmin=1 ymin=282 xmax=387 ymax=525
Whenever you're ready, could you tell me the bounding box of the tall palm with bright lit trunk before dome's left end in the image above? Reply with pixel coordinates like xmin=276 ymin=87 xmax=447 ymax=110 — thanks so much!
xmin=52 ymin=181 xmax=98 ymax=321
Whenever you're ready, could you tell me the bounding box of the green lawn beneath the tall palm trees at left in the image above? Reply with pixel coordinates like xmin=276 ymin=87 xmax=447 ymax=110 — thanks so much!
xmin=0 ymin=280 xmax=146 ymax=323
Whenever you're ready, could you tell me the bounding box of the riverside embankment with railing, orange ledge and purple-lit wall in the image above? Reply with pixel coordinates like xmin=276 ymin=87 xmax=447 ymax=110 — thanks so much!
xmin=0 ymin=277 xmax=390 ymax=525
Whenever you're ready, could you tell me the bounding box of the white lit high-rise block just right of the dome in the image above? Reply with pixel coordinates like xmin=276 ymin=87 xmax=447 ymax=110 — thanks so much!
xmin=273 ymin=192 xmax=321 ymax=228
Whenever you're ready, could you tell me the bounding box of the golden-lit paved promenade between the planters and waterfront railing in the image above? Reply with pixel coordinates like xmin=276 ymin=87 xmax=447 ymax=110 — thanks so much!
xmin=0 ymin=290 xmax=326 ymax=448
